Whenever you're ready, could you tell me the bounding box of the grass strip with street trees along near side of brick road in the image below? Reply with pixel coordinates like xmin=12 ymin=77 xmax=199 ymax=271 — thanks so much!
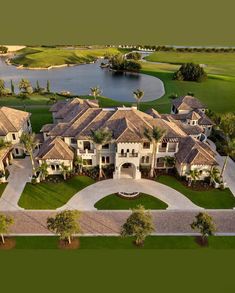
xmin=8 ymin=236 xmax=235 ymax=250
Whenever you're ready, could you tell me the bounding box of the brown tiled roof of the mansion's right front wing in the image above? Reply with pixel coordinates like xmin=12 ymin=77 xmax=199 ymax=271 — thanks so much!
xmin=175 ymin=136 xmax=217 ymax=165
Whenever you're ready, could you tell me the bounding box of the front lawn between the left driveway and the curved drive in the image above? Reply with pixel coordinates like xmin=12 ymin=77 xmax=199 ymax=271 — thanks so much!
xmin=18 ymin=176 xmax=95 ymax=210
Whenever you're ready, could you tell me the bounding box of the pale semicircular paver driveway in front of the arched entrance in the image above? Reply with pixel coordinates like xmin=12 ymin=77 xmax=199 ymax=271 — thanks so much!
xmin=58 ymin=179 xmax=202 ymax=211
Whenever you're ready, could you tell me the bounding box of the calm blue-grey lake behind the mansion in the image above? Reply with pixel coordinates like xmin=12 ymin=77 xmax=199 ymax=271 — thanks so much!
xmin=0 ymin=57 xmax=165 ymax=102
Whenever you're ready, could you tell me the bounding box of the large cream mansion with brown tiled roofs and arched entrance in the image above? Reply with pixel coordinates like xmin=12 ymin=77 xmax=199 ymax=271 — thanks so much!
xmin=37 ymin=97 xmax=216 ymax=179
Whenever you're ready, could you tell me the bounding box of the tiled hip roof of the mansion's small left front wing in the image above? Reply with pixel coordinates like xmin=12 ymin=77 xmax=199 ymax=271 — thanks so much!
xmin=37 ymin=137 xmax=74 ymax=160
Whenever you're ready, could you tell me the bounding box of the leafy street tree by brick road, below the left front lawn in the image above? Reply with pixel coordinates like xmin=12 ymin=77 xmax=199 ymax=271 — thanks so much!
xmin=47 ymin=210 xmax=81 ymax=244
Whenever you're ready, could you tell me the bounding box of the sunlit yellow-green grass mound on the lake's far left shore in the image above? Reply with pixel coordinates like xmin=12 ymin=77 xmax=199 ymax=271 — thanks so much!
xmin=13 ymin=47 xmax=120 ymax=68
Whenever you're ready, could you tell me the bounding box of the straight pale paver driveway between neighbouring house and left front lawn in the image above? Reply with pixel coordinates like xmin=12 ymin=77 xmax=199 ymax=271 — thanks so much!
xmin=0 ymin=157 xmax=32 ymax=211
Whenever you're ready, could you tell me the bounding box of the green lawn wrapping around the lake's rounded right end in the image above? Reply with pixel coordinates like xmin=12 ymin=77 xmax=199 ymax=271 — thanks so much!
xmin=141 ymin=62 xmax=235 ymax=113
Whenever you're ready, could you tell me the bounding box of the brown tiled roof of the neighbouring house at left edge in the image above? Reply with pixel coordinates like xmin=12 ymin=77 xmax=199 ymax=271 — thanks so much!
xmin=0 ymin=107 xmax=31 ymax=135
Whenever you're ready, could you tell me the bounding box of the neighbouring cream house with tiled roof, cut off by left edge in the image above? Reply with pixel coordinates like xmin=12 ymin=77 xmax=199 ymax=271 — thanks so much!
xmin=0 ymin=107 xmax=32 ymax=157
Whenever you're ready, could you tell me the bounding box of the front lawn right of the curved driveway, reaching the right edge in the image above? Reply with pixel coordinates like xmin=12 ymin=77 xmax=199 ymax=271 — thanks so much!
xmin=157 ymin=175 xmax=235 ymax=209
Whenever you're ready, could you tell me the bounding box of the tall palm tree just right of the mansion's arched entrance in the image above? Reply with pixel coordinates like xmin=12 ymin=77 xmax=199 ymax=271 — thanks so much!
xmin=144 ymin=126 xmax=165 ymax=177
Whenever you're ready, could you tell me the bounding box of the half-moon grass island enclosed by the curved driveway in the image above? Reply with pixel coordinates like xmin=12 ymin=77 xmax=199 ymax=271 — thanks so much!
xmin=95 ymin=193 xmax=168 ymax=210
